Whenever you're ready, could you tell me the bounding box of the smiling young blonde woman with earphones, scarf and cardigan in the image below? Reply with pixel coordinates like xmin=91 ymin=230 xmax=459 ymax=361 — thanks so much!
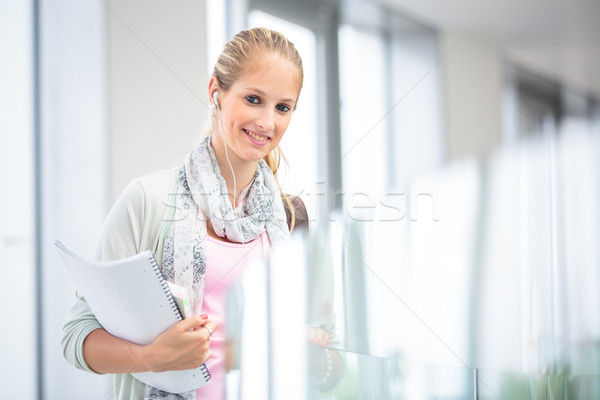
xmin=62 ymin=28 xmax=307 ymax=399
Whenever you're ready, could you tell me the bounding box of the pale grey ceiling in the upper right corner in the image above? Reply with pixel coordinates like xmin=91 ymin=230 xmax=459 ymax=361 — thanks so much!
xmin=378 ymin=0 xmax=600 ymax=99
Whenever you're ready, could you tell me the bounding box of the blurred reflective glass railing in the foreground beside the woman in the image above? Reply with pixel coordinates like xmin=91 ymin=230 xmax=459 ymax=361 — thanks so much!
xmin=224 ymin=124 xmax=600 ymax=399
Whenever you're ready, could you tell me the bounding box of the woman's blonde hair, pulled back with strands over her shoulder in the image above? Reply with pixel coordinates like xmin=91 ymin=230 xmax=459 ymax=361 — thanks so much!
xmin=213 ymin=28 xmax=304 ymax=232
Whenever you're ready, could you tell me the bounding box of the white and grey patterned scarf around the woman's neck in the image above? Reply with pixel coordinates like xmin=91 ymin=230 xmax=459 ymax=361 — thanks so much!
xmin=146 ymin=136 xmax=290 ymax=400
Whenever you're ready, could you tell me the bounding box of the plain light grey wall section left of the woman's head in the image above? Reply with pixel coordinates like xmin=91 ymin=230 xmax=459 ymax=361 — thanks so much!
xmin=108 ymin=0 xmax=212 ymax=202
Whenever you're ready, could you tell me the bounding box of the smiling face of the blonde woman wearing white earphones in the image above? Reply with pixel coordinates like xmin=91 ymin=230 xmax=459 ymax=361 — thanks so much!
xmin=209 ymin=54 xmax=300 ymax=162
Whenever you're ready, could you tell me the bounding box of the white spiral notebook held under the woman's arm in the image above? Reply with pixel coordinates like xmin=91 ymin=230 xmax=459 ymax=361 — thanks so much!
xmin=55 ymin=240 xmax=210 ymax=393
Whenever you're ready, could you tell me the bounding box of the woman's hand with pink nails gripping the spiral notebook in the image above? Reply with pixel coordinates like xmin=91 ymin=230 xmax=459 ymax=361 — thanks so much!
xmin=142 ymin=314 xmax=218 ymax=372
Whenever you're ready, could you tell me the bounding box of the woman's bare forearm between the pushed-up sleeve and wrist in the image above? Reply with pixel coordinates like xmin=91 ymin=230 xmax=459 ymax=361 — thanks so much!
xmin=83 ymin=329 xmax=152 ymax=374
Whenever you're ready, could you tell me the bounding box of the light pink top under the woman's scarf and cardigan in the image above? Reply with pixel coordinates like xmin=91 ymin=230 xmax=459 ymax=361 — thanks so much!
xmin=196 ymin=232 xmax=271 ymax=400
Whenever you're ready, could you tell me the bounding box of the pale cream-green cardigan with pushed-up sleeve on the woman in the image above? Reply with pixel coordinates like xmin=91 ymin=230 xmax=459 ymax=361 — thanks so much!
xmin=61 ymin=167 xmax=308 ymax=400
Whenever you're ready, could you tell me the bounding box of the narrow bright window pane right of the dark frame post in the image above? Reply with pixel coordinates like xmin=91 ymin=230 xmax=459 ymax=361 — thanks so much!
xmin=339 ymin=25 xmax=389 ymax=202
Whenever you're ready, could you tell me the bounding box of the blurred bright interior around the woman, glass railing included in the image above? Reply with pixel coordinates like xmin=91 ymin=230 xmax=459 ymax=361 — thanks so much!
xmin=0 ymin=0 xmax=600 ymax=399
